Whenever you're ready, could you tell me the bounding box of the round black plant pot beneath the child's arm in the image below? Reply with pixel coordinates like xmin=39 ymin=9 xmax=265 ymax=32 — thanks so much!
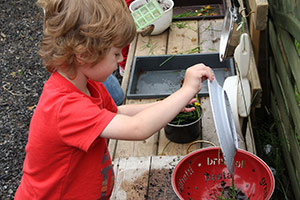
xmin=164 ymin=111 xmax=202 ymax=144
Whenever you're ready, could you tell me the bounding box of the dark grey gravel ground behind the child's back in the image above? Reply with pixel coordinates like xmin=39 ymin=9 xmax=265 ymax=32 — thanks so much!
xmin=0 ymin=0 xmax=121 ymax=200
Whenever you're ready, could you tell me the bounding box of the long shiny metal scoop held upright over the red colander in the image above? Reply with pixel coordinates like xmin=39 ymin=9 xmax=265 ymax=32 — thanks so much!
xmin=208 ymin=79 xmax=238 ymax=175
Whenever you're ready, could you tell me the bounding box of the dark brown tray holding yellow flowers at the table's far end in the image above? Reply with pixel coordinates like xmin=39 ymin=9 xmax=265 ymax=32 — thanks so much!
xmin=173 ymin=0 xmax=227 ymax=20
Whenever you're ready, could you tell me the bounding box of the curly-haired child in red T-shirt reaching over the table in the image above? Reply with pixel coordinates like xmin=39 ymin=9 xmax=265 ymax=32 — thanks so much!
xmin=15 ymin=0 xmax=214 ymax=200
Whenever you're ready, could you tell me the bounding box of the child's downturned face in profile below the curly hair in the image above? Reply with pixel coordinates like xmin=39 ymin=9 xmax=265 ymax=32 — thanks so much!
xmin=78 ymin=47 xmax=123 ymax=82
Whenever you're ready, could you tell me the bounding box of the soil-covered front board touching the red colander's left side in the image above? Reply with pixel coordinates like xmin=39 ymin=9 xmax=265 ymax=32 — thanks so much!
xmin=147 ymin=156 xmax=183 ymax=200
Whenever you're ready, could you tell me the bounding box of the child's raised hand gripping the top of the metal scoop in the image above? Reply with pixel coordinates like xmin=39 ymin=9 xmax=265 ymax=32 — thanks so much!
xmin=182 ymin=63 xmax=215 ymax=94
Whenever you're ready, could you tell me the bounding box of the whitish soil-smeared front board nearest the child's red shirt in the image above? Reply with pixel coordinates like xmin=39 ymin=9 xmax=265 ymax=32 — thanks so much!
xmin=111 ymin=157 xmax=151 ymax=200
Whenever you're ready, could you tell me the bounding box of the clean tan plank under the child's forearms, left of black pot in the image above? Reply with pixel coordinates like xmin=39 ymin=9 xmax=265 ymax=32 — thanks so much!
xmin=114 ymin=99 xmax=158 ymax=158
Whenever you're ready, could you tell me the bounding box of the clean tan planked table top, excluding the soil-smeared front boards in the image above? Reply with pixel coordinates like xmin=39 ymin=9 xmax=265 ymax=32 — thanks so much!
xmin=109 ymin=19 xmax=261 ymax=159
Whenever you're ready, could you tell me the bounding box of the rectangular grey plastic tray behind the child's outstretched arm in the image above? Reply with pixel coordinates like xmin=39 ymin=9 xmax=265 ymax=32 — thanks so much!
xmin=127 ymin=53 xmax=235 ymax=99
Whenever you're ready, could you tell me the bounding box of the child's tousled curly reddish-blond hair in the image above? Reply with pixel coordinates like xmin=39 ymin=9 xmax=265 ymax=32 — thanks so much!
xmin=37 ymin=0 xmax=136 ymax=78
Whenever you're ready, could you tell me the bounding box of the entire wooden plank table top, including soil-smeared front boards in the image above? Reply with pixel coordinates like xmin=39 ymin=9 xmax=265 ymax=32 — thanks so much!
xmin=109 ymin=2 xmax=261 ymax=199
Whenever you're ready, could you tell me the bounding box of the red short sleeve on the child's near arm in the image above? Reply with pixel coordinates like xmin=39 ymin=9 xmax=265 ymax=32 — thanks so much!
xmin=57 ymin=95 xmax=116 ymax=151
